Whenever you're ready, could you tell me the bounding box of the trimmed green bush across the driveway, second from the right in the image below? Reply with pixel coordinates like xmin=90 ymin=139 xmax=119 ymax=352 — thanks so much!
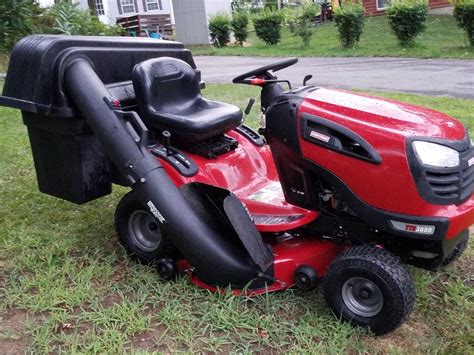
xmin=387 ymin=0 xmax=428 ymax=47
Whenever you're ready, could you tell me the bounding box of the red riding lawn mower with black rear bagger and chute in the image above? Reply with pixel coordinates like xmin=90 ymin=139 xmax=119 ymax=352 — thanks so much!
xmin=0 ymin=36 xmax=474 ymax=334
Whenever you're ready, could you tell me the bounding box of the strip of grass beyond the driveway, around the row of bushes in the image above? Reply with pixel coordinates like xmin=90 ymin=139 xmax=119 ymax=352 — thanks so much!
xmin=192 ymin=16 xmax=474 ymax=59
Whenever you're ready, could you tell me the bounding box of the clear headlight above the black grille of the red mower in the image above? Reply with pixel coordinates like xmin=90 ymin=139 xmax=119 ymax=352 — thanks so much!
xmin=413 ymin=141 xmax=459 ymax=168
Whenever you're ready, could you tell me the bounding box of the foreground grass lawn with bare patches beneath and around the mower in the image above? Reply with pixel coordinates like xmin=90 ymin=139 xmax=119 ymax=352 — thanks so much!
xmin=0 ymin=85 xmax=474 ymax=354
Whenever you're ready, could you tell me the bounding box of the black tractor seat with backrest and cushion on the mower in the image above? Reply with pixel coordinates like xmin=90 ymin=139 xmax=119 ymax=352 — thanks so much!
xmin=133 ymin=57 xmax=242 ymax=143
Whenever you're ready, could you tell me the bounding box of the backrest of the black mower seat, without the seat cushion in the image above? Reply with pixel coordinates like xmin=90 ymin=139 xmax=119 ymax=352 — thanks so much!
xmin=133 ymin=57 xmax=201 ymax=116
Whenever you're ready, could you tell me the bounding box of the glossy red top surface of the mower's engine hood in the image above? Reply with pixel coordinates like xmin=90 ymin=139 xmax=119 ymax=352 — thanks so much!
xmin=306 ymin=89 xmax=466 ymax=140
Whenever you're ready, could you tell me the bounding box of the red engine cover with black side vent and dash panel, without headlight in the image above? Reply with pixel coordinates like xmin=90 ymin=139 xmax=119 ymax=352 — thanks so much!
xmin=266 ymin=87 xmax=474 ymax=242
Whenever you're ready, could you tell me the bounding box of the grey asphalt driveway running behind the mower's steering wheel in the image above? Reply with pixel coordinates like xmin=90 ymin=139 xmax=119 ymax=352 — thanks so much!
xmin=194 ymin=56 xmax=474 ymax=99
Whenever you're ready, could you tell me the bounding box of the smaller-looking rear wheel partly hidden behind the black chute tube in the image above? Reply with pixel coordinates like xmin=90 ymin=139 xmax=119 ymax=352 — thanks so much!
xmin=115 ymin=191 xmax=175 ymax=264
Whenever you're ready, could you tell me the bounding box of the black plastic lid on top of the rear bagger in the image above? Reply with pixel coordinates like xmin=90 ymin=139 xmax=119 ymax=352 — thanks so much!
xmin=0 ymin=35 xmax=196 ymax=117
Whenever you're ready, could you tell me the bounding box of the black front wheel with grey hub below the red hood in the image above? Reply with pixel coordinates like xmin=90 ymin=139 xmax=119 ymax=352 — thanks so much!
xmin=324 ymin=246 xmax=415 ymax=335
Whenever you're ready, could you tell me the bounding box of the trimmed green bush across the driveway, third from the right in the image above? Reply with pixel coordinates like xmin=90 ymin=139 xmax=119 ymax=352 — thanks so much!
xmin=334 ymin=3 xmax=365 ymax=48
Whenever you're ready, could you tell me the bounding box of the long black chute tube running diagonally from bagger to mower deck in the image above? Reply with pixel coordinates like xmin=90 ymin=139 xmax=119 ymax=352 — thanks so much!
xmin=64 ymin=58 xmax=266 ymax=287
